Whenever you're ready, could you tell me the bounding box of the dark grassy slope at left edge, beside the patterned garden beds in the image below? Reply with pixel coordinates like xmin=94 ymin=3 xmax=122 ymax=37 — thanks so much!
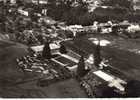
xmin=0 ymin=40 xmax=28 ymax=81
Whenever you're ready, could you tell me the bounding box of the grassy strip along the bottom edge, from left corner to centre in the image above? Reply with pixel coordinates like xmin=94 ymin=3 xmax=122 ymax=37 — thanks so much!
xmin=0 ymin=79 xmax=87 ymax=98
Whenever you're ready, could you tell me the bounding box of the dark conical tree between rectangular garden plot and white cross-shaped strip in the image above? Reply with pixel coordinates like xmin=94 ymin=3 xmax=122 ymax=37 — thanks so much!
xmin=77 ymin=56 xmax=88 ymax=78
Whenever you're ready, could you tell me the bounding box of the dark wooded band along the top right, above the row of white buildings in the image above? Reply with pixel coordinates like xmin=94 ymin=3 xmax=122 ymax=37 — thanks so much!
xmin=47 ymin=0 xmax=140 ymax=26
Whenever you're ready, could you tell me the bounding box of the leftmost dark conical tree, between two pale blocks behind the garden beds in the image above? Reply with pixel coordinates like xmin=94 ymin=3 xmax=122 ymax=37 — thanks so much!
xmin=42 ymin=42 xmax=52 ymax=59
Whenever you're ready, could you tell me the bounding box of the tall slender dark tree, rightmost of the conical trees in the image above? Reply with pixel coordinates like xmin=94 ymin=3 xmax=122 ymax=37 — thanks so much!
xmin=94 ymin=41 xmax=101 ymax=67
